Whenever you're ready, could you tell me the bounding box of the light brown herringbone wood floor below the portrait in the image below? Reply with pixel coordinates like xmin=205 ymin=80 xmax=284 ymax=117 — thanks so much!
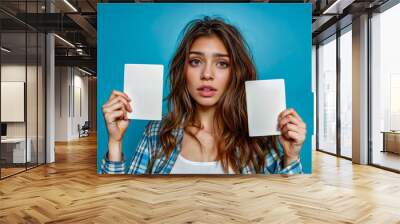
xmin=0 ymin=134 xmax=400 ymax=223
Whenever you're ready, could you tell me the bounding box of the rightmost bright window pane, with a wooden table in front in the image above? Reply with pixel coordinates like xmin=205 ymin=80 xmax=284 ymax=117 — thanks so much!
xmin=370 ymin=1 xmax=400 ymax=170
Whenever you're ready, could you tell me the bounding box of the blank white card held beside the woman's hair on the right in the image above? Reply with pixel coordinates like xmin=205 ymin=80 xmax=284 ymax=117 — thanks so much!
xmin=245 ymin=79 xmax=286 ymax=137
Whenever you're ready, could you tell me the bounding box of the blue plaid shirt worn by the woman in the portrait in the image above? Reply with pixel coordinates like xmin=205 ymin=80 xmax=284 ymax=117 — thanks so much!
xmin=100 ymin=121 xmax=303 ymax=174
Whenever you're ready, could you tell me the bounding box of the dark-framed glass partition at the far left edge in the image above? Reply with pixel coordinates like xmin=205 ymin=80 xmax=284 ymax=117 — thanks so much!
xmin=0 ymin=1 xmax=46 ymax=179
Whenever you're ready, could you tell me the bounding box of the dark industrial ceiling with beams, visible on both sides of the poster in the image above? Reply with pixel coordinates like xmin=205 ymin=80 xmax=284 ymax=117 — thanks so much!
xmin=0 ymin=0 xmax=394 ymax=73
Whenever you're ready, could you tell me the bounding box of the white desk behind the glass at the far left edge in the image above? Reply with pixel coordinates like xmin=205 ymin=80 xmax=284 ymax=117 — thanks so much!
xmin=1 ymin=138 xmax=32 ymax=163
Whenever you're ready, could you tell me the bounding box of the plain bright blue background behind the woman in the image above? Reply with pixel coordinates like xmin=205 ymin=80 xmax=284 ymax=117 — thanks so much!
xmin=97 ymin=3 xmax=314 ymax=173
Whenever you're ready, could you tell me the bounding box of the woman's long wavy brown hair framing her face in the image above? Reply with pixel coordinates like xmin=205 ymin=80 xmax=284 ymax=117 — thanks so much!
xmin=150 ymin=17 xmax=279 ymax=173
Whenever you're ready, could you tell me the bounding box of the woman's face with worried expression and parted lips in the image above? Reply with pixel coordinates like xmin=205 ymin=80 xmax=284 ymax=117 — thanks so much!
xmin=185 ymin=36 xmax=231 ymax=107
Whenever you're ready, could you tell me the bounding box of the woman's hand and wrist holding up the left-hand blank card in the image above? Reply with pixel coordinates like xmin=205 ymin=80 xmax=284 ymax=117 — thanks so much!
xmin=102 ymin=90 xmax=132 ymax=161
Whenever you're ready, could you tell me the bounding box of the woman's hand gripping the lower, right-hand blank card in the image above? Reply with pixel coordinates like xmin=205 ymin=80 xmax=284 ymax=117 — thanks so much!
xmin=278 ymin=109 xmax=307 ymax=167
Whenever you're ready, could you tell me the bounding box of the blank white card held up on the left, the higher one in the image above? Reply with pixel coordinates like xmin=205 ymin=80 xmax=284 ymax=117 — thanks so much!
xmin=124 ymin=64 xmax=164 ymax=120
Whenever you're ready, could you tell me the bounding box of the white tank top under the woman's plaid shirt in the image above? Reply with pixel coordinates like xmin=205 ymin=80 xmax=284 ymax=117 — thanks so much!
xmin=170 ymin=154 xmax=235 ymax=174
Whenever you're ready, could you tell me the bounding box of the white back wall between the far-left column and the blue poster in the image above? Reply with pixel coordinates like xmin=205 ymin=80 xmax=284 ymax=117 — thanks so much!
xmin=55 ymin=67 xmax=88 ymax=141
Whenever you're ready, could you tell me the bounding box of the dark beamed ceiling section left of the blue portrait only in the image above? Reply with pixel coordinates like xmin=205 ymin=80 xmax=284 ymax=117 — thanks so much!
xmin=0 ymin=0 xmax=97 ymax=74
